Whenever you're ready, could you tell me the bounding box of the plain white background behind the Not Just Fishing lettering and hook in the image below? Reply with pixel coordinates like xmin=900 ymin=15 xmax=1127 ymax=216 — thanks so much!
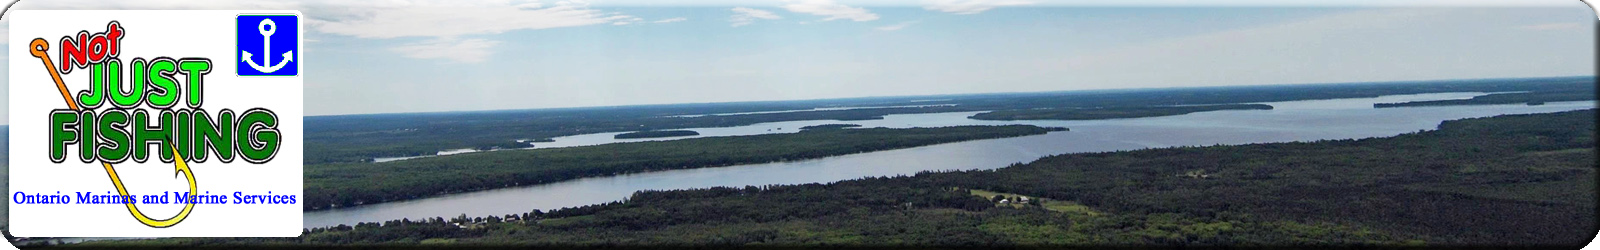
xmin=5 ymin=10 xmax=304 ymax=237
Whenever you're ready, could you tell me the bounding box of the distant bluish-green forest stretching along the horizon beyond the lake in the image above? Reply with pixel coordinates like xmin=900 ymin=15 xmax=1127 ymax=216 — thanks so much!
xmin=304 ymin=77 xmax=1595 ymax=163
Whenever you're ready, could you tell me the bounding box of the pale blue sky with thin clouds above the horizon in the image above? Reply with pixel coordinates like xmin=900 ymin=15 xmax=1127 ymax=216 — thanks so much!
xmin=0 ymin=0 xmax=1597 ymax=123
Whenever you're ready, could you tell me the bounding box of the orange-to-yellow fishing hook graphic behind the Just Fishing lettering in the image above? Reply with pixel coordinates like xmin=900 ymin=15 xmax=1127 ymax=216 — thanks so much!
xmin=29 ymin=38 xmax=198 ymax=228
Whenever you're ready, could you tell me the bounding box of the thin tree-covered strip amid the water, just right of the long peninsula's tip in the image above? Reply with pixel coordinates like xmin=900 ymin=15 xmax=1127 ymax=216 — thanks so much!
xmin=968 ymin=104 xmax=1272 ymax=120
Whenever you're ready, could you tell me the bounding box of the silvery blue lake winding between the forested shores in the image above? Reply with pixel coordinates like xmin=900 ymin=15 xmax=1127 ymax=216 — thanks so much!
xmin=304 ymin=93 xmax=1595 ymax=228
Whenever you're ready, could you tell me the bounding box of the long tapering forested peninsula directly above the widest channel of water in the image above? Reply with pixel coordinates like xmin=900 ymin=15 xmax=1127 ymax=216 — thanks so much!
xmin=301 ymin=125 xmax=1058 ymax=210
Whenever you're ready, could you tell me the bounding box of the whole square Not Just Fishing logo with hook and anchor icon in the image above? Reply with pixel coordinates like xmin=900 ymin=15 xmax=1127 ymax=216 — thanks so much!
xmin=8 ymin=11 xmax=304 ymax=237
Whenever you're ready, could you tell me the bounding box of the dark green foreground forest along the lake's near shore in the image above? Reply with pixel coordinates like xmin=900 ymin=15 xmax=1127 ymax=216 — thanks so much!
xmin=100 ymin=109 xmax=1597 ymax=247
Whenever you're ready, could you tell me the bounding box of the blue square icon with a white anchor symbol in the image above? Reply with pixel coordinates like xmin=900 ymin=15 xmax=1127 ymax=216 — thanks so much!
xmin=235 ymin=14 xmax=301 ymax=75
